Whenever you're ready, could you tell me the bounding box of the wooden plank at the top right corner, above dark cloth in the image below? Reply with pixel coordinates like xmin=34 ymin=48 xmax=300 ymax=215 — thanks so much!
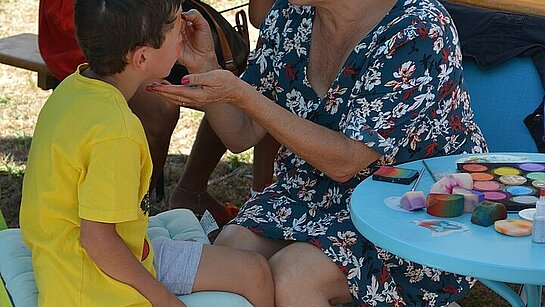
xmin=447 ymin=0 xmax=545 ymax=17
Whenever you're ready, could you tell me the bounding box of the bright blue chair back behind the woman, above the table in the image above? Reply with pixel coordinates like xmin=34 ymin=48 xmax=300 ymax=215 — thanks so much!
xmin=463 ymin=58 xmax=544 ymax=152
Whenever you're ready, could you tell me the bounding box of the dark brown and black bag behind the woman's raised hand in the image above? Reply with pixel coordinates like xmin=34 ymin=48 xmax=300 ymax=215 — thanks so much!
xmin=183 ymin=0 xmax=250 ymax=76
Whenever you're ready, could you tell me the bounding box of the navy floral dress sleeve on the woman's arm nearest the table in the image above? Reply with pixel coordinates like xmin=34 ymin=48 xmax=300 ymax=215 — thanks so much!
xmin=340 ymin=21 xmax=464 ymax=157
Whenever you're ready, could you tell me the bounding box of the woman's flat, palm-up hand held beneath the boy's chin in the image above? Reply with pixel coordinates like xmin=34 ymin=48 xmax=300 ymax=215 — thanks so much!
xmin=146 ymin=69 xmax=246 ymax=110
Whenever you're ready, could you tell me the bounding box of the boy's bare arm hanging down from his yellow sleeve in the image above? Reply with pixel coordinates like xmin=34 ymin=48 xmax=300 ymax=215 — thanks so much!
xmin=80 ymin=219 xmax=185 ymax=307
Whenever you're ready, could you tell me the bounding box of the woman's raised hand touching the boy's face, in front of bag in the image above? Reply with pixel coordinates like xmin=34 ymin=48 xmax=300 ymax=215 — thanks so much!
xmin=178 ymin=9 xmax=219 ymax=73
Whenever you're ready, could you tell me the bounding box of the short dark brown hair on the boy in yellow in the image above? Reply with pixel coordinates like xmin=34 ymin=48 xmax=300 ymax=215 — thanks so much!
xmin=74 ymin=0 xmax=183 ymax=75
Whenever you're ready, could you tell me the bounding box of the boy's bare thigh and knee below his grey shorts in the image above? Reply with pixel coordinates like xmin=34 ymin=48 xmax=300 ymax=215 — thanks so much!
xmin=193 ymin=245 xmax=275 ymax=307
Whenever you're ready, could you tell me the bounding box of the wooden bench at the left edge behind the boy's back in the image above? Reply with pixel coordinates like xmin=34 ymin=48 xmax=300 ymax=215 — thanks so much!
xmin=0 ymin=33 xmax=59 ymax=90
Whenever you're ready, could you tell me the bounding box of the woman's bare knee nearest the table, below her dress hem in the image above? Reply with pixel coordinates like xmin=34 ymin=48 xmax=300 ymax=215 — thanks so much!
xmin=269 ymin=242 xmax=352 ymax=306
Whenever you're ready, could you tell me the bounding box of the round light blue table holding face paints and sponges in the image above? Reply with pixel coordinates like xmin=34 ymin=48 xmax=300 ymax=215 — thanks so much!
xmin=350 ymin=153 xmax=545 ymax=307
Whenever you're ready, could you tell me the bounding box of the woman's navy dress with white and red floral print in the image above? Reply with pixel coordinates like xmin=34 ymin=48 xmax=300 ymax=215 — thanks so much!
xmin=231 ymin=0 xmax=487 ymax=306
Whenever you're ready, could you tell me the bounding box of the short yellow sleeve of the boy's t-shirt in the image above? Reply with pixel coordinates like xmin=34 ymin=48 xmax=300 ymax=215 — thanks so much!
xmin=78 ymin=138 xmax=142 ymax=223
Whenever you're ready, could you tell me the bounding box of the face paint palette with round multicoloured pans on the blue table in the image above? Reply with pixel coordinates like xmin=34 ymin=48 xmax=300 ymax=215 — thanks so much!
xmin=457 ymin=162 xmax=545 ymax=211
